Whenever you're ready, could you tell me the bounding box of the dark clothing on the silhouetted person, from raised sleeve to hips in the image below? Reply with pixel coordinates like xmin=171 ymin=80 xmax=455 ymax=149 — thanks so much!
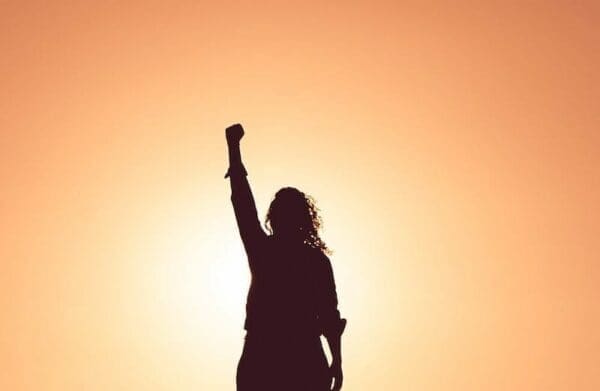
xmin=226 ymin=162 xmax=342 ymax=391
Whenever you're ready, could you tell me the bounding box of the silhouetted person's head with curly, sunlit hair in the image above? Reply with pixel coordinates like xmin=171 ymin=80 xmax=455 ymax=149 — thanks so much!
xmin=265 ymin=187 xmax=329 ymax=253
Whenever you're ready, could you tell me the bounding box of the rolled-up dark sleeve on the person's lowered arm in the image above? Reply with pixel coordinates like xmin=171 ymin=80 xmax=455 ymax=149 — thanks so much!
xmin=317 ymin=254 xmax=346 ymax=337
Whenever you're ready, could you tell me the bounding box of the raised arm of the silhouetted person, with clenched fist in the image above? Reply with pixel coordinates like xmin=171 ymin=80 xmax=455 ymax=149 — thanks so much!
xmin=225 ymin=124 xmax=266 ymax=269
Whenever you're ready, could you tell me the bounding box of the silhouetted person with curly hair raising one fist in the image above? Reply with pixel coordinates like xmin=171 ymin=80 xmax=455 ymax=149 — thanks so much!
xmin=225 ymin=124 xmax=346 ymax=391
